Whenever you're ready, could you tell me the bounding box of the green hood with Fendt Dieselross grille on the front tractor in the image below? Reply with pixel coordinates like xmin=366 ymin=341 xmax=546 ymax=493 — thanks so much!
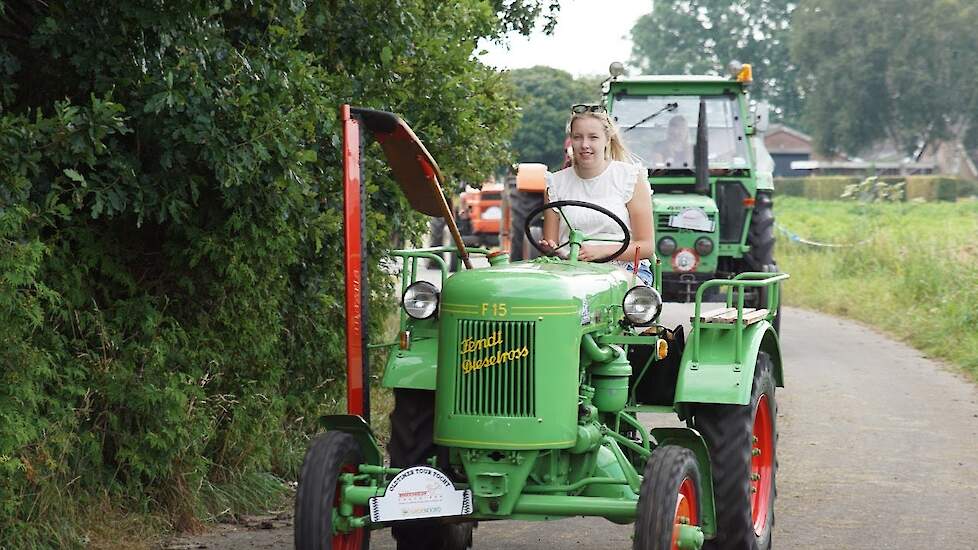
xmin=434 ymin=258 xmax=630 ymax=452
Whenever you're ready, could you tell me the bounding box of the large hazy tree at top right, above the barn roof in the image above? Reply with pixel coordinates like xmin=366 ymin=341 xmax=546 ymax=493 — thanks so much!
xmin=792 ymin=0 xmax=978 ymax=154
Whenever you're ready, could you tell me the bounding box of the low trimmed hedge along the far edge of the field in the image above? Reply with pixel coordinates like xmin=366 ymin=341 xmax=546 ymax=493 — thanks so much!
xmin=774 ymin=175 xmax=978 ymax=201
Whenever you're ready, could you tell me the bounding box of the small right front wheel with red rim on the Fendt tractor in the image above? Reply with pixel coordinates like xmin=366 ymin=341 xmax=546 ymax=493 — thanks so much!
xmin=632 ymin=445 xmax=702 ymax=550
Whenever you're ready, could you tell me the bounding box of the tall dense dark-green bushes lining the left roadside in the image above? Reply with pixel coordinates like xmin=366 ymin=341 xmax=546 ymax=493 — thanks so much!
xmin=0 ymin=0 xmax=542 ymax=548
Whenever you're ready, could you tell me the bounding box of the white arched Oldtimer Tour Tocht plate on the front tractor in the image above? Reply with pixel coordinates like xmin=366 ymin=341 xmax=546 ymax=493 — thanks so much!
xmin=369 ymin=466 xmax=472 ymax=523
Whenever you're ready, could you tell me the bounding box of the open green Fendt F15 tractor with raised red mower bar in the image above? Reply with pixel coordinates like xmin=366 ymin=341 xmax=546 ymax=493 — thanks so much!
xmin=295 ymin=106 xmax=787 ymax=550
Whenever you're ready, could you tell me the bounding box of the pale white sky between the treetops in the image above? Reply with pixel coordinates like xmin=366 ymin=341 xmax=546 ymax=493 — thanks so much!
xmin=479 ymin=0 xmax=652 ymax=76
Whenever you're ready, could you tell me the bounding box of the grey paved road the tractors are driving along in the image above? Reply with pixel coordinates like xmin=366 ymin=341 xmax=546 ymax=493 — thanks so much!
xmin=164 ymin=305 xmax=978 ymax=550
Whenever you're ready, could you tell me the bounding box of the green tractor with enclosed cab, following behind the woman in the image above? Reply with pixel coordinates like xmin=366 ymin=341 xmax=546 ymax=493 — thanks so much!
xmin=603 ymin=63 xmax=778 ymax=324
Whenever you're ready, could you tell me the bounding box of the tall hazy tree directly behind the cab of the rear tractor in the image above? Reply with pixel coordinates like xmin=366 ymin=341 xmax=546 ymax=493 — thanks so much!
xmin=632 ymin=0 xmax=801 ymax=124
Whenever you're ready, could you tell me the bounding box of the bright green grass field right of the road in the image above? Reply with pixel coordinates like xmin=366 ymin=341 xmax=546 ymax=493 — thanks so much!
xmin=775 ymin=197 xmax=978 ymax=382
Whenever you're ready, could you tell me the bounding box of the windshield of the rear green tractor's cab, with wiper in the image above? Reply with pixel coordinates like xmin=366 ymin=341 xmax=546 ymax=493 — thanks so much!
xmin=612 ymin=95 xmax=750 ymax=171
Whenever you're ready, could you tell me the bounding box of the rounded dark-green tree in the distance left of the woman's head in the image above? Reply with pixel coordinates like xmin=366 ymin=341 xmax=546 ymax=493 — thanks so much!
xmin=508 ymin=66 xmax=601 ymax=170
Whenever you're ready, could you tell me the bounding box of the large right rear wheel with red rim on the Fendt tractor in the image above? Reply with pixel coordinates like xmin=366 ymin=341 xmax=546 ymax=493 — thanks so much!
xmin=693 ymin=352 xmax=778 ymax=550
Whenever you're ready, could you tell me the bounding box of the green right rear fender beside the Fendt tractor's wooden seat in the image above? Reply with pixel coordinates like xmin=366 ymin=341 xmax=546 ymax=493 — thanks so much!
xmin=675 ymin=321 xmax=784 ymax=405
